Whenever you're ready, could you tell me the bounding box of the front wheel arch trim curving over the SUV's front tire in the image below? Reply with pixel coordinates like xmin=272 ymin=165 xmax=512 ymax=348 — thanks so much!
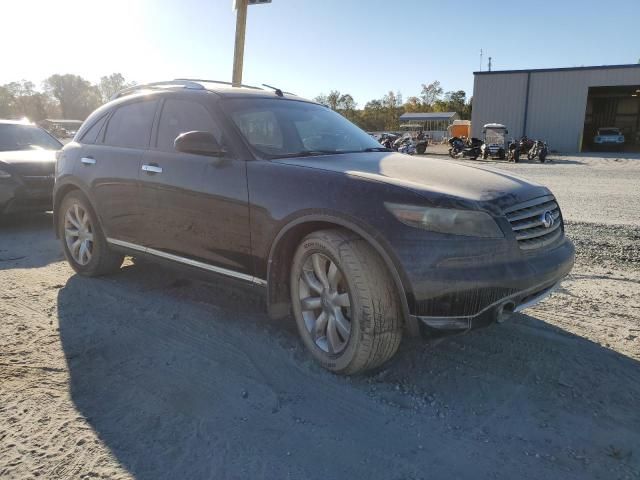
xmin=267 ymin=214 xmax=419 ymax=335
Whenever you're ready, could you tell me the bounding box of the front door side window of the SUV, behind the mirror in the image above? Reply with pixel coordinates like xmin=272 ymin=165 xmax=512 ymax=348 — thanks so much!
xmin=157 ymin=98 xmax=221 ymax=152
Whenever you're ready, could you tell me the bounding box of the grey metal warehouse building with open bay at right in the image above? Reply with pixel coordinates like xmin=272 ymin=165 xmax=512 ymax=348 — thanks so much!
xmin=471 ymin=64 xmax=640 ymax=152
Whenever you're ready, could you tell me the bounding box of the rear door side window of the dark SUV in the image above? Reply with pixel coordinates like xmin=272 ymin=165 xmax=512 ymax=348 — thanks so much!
xmin=104 ymin=100 xmax=158 ymax=148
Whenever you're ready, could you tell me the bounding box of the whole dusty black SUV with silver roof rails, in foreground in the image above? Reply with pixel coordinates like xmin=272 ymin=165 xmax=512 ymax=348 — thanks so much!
xmin=54 ymin=80 xmax=574 ymax=374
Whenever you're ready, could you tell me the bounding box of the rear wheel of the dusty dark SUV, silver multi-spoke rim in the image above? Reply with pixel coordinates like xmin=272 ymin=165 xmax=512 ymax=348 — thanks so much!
xmin=57 ymin=190 xmax=124 ymax=277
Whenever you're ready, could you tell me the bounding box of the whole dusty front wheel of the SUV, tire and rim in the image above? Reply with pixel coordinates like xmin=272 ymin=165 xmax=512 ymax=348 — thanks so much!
xmin=290 ymin=230 xmax=402 ymax=375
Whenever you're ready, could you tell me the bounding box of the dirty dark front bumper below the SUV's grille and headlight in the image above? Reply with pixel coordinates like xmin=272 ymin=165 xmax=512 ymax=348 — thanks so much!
xmin=404 ymin=237 xmax=575 ymax=336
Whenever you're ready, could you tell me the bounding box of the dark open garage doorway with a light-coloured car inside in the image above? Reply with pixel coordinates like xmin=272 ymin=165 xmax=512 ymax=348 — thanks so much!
xmin=582 ymin=85 xmax=640 ymax=152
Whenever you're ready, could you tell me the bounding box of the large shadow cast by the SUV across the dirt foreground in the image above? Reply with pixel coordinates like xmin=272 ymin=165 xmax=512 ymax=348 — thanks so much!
xmin=58 ymin=264 xmax=640 ymax=480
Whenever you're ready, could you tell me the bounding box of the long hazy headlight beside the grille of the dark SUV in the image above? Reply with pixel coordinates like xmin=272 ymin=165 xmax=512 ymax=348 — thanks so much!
xmin=384 ymin=202 xmax=504 ymax=238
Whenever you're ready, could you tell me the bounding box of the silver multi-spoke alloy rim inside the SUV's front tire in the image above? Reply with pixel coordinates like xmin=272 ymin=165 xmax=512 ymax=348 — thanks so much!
xmin=299 ymin=253 xmax=351 ymax=354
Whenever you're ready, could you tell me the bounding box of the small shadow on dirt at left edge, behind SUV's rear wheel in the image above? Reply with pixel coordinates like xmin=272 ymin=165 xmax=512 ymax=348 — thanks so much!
xmin=0 ymin=213 xmax=63 ymax=270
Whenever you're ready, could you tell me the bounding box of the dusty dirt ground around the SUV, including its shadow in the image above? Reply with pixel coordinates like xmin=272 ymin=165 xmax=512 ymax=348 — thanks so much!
xmin=0 ymin=156 xmax=640 ymax=480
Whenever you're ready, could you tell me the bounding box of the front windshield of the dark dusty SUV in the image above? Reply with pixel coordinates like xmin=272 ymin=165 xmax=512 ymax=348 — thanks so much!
xmin=223 ymin=98 xmax=386 ymax=158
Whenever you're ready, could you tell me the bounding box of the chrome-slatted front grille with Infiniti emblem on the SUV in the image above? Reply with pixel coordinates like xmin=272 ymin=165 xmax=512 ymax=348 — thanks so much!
xmin=504 ymin=195 xmax=563 ymax=250
